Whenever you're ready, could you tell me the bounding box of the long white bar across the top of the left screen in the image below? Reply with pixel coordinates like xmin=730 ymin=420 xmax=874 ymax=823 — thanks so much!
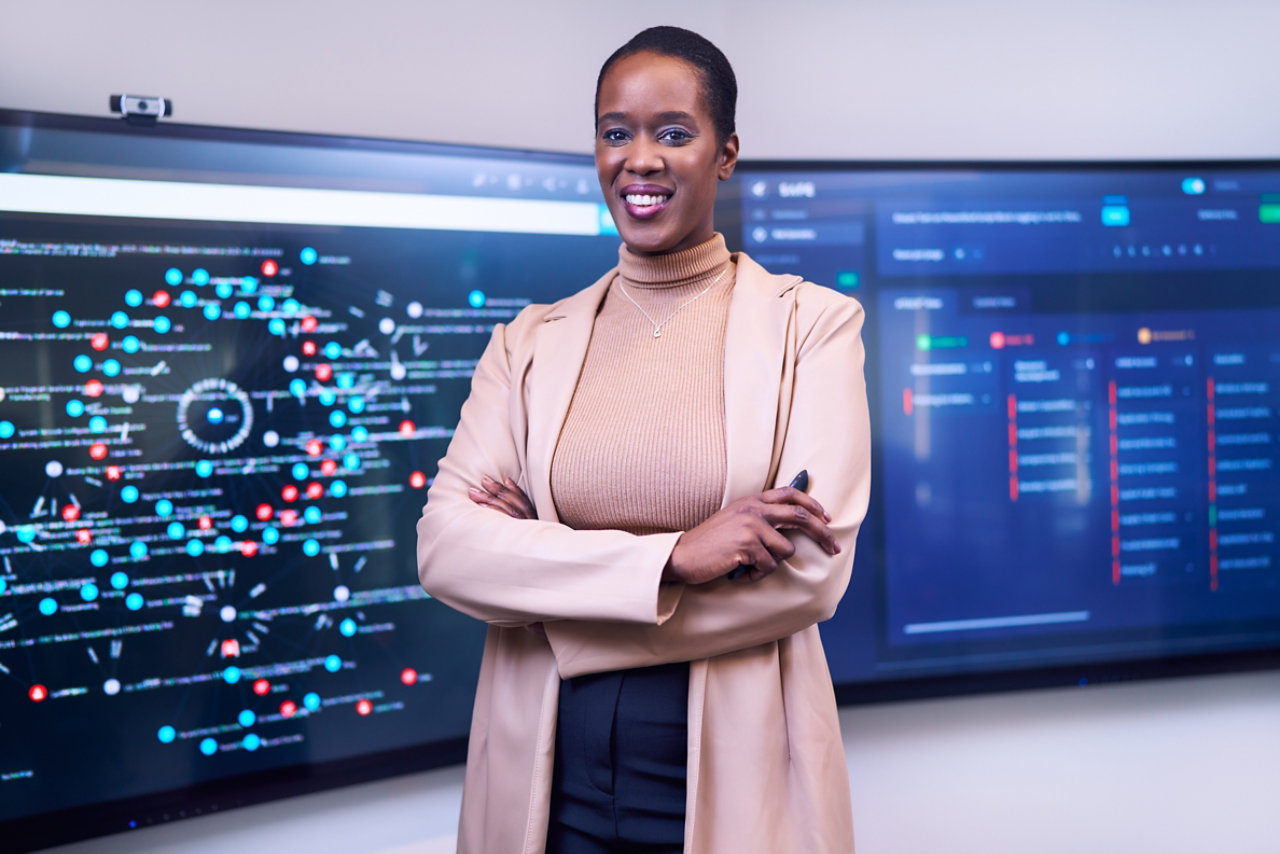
xmin=0 ymin=174 xmax=617 ymax=236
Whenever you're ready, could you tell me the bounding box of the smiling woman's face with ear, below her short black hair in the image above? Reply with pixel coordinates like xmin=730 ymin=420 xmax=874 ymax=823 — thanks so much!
xmin=595 ymin=52 xmax=737 ymax=255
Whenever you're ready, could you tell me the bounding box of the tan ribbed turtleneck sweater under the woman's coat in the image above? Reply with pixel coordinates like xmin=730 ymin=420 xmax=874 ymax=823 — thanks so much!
xmin=550 ymin=234 xmax=736 ymax=534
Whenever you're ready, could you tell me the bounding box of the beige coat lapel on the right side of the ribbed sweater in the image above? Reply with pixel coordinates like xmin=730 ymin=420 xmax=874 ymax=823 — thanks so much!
xmin=722 ymin=252 xmax=801 ymax=504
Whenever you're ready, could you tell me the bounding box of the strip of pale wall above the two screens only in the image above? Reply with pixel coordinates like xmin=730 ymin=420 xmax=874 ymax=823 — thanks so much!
xmin=0 ymin=0 xmax=1280 ymax=157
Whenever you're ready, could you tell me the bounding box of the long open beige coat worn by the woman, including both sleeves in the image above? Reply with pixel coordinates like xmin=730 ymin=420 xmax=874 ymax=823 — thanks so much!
xmin=417 ymin=254 xmax=870 ymax=854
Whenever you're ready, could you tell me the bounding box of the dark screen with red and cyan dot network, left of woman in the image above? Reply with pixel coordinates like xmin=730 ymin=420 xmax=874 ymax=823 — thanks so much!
xmin=0 ymin=108 xmax=617 ymax=846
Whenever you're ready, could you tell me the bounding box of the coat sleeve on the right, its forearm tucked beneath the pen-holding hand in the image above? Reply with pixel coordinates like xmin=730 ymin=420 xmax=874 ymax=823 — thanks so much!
xmin=545 ymin=289 xmax=870 ymax=679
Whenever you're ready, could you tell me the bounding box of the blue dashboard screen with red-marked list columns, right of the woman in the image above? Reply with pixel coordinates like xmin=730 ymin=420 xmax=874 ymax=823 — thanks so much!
xmin=741 ymin=164 xmax=1280 ymax=684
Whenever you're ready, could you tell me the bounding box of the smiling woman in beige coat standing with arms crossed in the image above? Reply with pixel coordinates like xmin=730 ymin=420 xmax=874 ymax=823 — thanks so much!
xmin=417 ymin=27 xmax=869 ymax=854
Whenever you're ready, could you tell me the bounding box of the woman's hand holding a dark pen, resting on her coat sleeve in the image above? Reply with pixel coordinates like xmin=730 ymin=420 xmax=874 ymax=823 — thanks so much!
xmin=663 ymin=487 xmax=841 ymax=584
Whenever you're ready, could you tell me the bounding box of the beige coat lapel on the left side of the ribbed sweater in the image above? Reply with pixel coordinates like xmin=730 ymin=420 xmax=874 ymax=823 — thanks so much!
xmin=526 ymin=270 xmax=617 ymax=521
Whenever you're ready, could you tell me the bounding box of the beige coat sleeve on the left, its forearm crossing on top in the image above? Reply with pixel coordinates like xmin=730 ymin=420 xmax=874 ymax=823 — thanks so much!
xmin=417 ymin=306 xmax=681 ymax=626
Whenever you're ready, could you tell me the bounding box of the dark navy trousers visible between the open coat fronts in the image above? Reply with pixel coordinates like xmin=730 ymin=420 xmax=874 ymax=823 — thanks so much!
xmin=547 ymin=663 xmax=689 ymax=854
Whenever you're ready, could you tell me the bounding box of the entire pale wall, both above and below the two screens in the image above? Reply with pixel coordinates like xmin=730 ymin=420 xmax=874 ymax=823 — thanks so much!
xmin=10 ymin=0 xmax=1280 ymax=854
